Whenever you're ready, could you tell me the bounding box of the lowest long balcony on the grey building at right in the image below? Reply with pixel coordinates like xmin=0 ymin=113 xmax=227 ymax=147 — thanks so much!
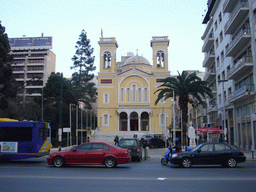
xmin=228 ymin=85 xmax=255 ymax=103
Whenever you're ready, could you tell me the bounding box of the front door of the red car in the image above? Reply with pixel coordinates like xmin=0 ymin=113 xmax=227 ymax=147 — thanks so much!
xmin=66 ymin=143 xmax=92 ymax=164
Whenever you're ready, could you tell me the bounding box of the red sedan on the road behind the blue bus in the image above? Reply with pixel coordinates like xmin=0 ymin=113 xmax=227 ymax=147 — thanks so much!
xmin=47 ymin=142 xmax=131 ymax=168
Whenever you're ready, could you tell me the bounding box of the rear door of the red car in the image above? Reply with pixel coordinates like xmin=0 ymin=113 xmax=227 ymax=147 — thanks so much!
xmin=88 ymin=143 xmax=109 ymax=165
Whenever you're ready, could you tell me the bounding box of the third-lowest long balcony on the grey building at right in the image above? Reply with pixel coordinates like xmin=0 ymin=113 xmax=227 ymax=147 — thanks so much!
xmin=226 ymin=28 xmax=251 ymax=57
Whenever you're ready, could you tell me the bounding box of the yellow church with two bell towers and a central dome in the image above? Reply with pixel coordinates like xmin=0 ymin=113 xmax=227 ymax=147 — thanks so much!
xmin=94 ymin=36 xmax=172 ymax=142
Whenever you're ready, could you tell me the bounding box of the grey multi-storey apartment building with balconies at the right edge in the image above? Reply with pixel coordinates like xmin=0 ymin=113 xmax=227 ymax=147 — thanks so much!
xmin=202 ymin=0 xmax=256 ymax=150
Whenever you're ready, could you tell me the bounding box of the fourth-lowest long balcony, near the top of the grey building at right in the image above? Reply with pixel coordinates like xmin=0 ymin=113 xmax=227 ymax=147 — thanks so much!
xmin=224 ymin=2 xmax=249 ymax=34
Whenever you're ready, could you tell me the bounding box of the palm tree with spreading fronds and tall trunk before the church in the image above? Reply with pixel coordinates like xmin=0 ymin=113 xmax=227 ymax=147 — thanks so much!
xmin=155 ymin=71 xmax=212 ymax=144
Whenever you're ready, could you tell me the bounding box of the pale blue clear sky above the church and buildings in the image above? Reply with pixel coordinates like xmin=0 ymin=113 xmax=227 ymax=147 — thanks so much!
xmin=0 ymin=0 xmax=207 ymax=78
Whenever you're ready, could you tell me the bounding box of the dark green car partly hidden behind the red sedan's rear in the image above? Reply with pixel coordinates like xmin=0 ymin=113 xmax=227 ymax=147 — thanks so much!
xmin=118 ymin=138 xmax=142 ymax=161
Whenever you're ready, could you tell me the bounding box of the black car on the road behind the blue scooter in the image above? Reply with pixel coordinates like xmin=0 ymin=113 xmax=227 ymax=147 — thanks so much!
xmin=170 ymin=142 xmax=246 ymax=168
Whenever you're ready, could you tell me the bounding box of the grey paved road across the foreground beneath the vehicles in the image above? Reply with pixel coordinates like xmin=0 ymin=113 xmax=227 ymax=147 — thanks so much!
xmin=0 ymin=149 xmax=256 ymax=192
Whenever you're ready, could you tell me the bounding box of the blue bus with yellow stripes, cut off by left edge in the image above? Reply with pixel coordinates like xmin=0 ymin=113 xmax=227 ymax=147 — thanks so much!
xmin=0 ymin=118 xmax=51 ymax=160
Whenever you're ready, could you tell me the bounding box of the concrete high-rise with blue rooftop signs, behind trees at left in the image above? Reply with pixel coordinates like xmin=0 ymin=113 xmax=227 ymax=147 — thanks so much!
xmin=9 ymin=34 xmax=56 ymax=99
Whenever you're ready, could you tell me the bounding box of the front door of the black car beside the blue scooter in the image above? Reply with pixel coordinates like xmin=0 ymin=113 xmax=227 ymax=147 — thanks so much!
xmin=191 ymin=143 xmax=213 ymax=164
